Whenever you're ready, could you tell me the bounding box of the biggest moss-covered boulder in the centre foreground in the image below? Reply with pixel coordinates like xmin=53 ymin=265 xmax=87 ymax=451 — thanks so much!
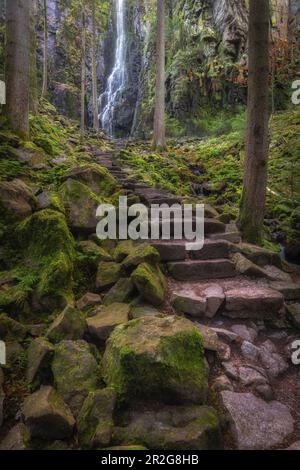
xmin=103 ymin=317 xmax=208 ymax=404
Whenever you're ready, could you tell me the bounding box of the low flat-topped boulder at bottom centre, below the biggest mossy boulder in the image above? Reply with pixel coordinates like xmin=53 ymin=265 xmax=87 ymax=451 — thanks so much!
xmin=114 ymin=406 xmax=222 ymax=450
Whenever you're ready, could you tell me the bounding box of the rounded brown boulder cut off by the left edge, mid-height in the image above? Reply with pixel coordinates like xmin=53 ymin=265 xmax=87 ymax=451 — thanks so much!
xmin=0 ymin=179 xmax=37 ymax=222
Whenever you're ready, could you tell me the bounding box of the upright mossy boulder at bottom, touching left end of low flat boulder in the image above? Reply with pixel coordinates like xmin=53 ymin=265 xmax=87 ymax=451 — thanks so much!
xmin=77 ymin=388 xmax=116 ymax=448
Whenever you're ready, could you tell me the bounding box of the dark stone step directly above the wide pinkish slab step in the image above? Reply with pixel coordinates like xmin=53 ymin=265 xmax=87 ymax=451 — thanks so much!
xmin=168 ymin=259 xmax=237 ymax=281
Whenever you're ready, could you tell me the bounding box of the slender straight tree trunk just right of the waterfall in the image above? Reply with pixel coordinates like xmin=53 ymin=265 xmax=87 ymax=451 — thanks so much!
xmin=153 ymin=0 xmax=166 ymax=150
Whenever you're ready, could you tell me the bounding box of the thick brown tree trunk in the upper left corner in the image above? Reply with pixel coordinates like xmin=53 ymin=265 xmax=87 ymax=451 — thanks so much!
xmin=5 ymin=0 xmax=30 ymax=138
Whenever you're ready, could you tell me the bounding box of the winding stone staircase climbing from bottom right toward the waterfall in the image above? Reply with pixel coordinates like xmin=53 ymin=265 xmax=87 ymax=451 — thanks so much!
xmin=91 ymin=147 xmax=300 ymax=448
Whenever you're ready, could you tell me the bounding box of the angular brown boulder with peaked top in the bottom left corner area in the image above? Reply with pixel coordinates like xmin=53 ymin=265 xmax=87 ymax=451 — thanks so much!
xmin=22 ymin=386 xmax=75 ymax=439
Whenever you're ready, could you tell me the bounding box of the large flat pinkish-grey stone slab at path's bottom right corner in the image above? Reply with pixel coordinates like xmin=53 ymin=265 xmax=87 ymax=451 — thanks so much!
xmin=221 ymin=391 xmax=294 ymax=450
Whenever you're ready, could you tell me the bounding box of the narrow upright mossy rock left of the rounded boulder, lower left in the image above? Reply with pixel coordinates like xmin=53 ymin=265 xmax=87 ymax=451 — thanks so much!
xmin=26 ymin=337 xmax=54 ymax=385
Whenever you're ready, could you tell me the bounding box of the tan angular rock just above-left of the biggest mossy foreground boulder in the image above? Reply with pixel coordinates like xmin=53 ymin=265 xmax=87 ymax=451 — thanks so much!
xmin=87 ymin=303 xmax=130 ymax=341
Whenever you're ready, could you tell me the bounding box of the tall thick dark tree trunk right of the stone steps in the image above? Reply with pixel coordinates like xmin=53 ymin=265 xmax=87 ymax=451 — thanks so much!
xmin=240 ymin=0 xmax=270 ymax=243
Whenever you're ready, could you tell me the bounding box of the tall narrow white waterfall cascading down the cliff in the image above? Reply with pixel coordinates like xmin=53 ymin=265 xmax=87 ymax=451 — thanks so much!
xmin=99 ymin=0 xmax=126 ymax=136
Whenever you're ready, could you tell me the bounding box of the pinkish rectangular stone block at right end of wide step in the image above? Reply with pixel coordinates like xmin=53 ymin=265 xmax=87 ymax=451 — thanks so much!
xmin=224 ymin=286 xmax=283 ymax=320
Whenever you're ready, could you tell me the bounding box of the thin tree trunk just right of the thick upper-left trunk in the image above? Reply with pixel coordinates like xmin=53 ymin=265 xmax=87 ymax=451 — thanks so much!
xmin=29 ymin=0 xmax=38 ymax=114
